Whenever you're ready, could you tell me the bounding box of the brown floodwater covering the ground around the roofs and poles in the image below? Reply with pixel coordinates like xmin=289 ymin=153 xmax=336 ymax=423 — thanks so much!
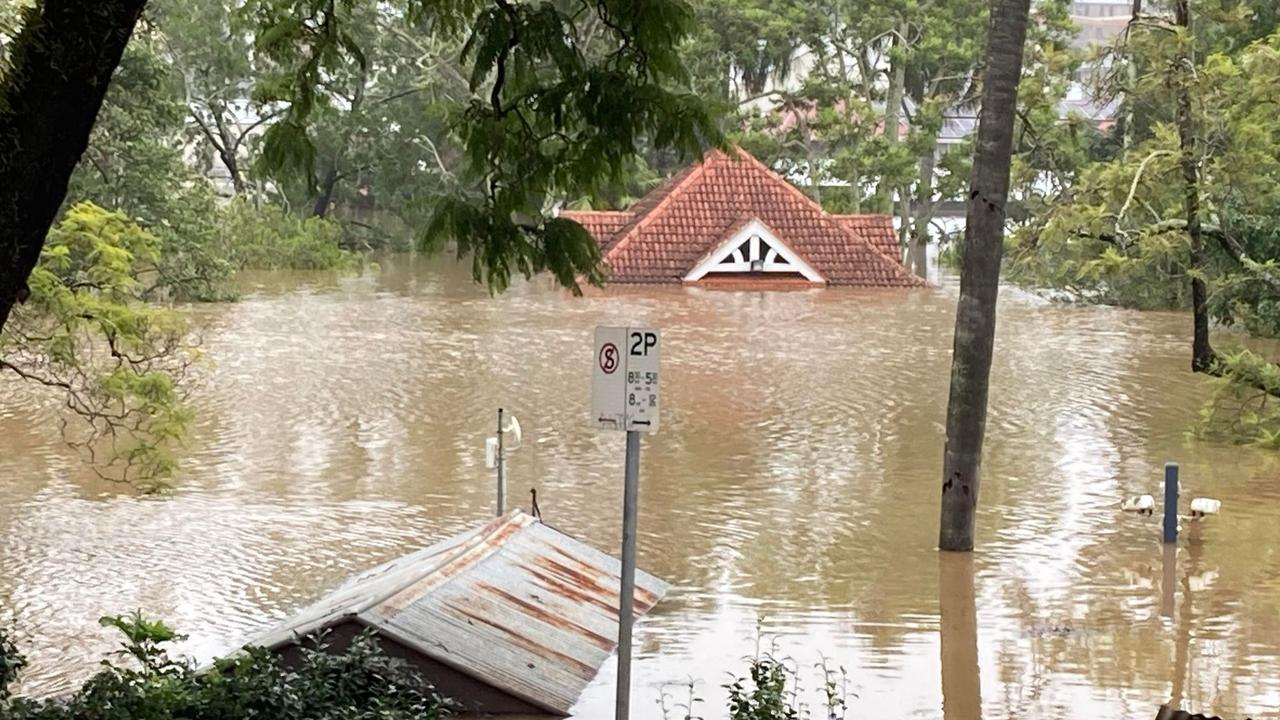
xmin=0 ymin=258 xmax=1280 ymax=720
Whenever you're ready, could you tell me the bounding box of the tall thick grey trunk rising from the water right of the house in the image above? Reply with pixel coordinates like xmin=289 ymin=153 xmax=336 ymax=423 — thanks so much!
xmin=938 ymin=0 xmax=1030 ymax=551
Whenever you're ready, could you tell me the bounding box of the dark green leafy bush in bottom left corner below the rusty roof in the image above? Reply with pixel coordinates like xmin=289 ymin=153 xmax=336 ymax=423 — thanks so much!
xmin=0 ymin=614 xmax=449 ymax=720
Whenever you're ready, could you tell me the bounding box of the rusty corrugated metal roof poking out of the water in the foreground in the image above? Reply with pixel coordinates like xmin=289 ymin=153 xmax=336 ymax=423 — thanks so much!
xmin=248 ymin=510 xmax=667 ymax=714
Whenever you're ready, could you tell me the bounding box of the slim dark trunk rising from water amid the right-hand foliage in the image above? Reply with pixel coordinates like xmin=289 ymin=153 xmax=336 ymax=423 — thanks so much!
xmin=1172 ymin=0 xmax=1216 ymax=373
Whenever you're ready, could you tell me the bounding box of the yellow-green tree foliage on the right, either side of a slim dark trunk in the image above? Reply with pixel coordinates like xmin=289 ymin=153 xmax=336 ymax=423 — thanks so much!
xmin=1011 ymin=22 xmax=1280 ymax=334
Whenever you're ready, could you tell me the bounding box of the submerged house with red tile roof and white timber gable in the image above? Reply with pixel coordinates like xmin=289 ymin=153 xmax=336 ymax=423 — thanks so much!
xmin=561 ymin=149 xmax=925 ymax=288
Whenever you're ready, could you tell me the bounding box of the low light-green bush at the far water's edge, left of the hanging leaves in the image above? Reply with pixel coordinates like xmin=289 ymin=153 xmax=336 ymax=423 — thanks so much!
xmin=219 ymin=200 xmax=356 ymax=270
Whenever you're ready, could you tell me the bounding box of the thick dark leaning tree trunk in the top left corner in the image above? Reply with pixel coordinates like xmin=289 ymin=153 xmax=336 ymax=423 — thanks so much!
xmin=0 ymin=0 xmax=146 ymax=329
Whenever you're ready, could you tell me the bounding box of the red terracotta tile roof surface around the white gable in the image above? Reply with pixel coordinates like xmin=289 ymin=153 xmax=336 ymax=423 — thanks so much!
xmin=563 ymin=150 xmax=925 ymax=287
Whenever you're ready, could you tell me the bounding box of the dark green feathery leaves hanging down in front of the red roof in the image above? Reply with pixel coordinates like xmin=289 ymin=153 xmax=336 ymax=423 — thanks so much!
xmin=252 ymin=0 xmax=721 ymax=291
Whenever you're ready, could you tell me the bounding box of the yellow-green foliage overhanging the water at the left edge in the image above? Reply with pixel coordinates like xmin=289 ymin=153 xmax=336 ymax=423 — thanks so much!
xmin=0 ymin=202 xmax=198 ymax=488
